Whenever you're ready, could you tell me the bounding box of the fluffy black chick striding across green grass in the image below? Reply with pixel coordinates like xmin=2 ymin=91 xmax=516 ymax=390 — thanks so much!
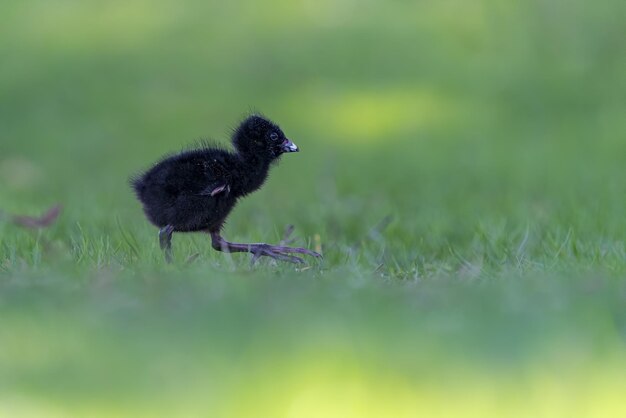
xmin=131 ymin=115 xmax=320 ymax=263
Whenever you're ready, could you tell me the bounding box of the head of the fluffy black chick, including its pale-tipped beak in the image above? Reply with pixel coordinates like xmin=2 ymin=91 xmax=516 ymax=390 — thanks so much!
xmin=233 ymin=115 xmax=298 ymax=160
